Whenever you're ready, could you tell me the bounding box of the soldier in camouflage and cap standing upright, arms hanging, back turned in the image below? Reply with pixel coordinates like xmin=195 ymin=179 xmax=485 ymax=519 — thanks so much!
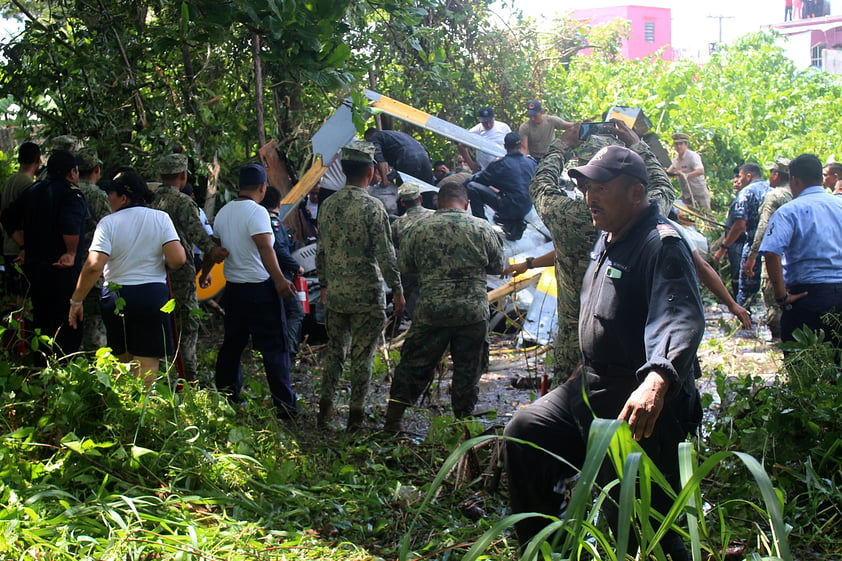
xmin=316 ymin=141 xmax=405 ymax=431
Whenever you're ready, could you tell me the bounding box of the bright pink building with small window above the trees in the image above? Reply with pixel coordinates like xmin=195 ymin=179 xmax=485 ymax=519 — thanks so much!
xmin=573 ymin=5 xmax=673 ymax=60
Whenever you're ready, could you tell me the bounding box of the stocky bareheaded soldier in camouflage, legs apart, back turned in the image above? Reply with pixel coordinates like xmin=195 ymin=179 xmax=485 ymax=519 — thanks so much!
xmin=384 ymin=182 xmax=503 ymax=432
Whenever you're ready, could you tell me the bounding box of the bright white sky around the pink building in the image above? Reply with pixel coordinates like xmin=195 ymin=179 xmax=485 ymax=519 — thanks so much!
xmin=496 ymin=0 xmax=784 ymax=58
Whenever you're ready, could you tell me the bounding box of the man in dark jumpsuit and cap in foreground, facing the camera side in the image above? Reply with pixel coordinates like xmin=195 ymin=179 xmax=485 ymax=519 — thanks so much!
xmin=506 ymin=146 xmax=704 ymax=561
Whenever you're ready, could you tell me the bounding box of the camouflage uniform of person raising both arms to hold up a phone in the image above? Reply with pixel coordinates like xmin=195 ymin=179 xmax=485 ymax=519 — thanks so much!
xmin=529 ymin=137 xmax=675 ymax=384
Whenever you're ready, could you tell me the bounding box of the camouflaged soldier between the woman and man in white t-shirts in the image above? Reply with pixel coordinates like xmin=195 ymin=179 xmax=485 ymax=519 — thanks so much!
xmin=150 ymin=154 xmax=228 ymax=381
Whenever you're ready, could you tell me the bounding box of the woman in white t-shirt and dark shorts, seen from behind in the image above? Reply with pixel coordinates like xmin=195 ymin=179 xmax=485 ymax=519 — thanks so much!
xmin=68 ymin=171 xmax=186 ymax=385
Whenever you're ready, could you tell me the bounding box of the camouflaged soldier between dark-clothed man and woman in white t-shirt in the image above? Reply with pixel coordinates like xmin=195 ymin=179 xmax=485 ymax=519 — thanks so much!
xmin=76 ymin=148 xmax=111 ymax=351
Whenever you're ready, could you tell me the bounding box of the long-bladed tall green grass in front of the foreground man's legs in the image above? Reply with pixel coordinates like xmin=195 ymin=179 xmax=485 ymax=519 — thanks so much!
xmin=400 ymin=419 xmax=793 ymax=561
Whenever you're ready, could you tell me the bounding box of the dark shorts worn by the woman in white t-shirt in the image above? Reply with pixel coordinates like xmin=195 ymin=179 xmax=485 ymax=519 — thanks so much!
xmin=100 ymin=283 xmax=175 ymax=358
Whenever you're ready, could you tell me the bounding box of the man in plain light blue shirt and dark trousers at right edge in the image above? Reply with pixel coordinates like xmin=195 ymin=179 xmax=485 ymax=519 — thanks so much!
xmin=760 ymin=154 xmax=842 ymax=347
